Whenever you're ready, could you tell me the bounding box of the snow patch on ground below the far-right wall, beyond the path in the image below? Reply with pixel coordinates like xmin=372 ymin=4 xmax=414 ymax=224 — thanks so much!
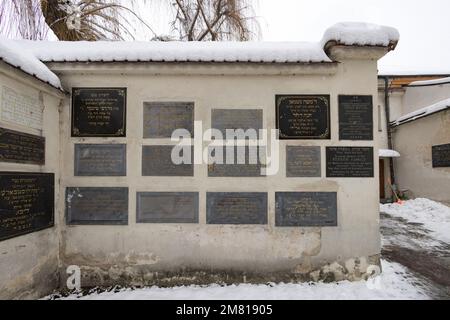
xmin=380 ymin=198 xmax=450 ymax=244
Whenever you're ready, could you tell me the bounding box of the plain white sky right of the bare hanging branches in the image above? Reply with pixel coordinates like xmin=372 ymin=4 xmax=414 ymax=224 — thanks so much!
xmin=256 ymin=0 xmax=450 ymax=74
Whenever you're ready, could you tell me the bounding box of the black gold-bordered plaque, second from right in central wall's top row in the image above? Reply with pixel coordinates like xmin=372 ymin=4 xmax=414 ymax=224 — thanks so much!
xmin=275 ymin=95 xmax=331 ymax=139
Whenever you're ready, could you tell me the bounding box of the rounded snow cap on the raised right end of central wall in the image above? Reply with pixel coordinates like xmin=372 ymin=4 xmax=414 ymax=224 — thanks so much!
xmin=321 ymin=22 xmax=400 ymax=50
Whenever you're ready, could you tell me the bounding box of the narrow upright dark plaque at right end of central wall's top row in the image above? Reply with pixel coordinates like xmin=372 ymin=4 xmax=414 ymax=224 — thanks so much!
xmin=339 ymin=95 xmax=373 ymax=140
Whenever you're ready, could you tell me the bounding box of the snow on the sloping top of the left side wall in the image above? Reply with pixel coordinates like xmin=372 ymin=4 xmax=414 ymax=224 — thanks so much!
xmin=0 ymin=38 xmax=61 ymax=89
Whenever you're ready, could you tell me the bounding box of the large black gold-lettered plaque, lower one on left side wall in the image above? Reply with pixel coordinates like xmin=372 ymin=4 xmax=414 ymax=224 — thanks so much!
xmin=0 ymin=172 xmax=55 ymax=241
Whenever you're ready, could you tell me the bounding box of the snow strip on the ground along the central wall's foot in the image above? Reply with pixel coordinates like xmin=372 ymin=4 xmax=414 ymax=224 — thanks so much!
xmin=49 ymin=261 xmax=429 ymax=300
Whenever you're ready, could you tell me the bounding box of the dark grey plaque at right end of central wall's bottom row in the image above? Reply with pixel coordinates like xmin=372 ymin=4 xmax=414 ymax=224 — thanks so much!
xmin=275 ymin=192 xmax=337 ymax=227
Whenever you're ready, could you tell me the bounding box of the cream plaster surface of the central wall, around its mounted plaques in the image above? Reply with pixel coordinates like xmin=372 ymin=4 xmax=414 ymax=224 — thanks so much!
xmin=52 ymin=57 xmax=380 ymax=286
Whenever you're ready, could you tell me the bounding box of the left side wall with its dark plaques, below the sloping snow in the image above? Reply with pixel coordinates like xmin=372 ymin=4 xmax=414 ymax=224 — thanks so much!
xmin=0 ymin=64 xmax=63 ymax=299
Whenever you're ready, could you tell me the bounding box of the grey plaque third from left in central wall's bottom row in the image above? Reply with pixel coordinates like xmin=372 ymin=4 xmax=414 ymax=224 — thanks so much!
xmin=206 ymin=192 xmax=267 ymax=224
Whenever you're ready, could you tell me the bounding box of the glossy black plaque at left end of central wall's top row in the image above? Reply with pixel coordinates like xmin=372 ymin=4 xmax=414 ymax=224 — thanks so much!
xmin=72 ymin=88 xmax=127 ymax=137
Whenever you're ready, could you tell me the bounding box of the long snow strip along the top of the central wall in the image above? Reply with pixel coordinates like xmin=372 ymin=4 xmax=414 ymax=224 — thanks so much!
xmin=17 ymin=41 xmax=332 ymax=63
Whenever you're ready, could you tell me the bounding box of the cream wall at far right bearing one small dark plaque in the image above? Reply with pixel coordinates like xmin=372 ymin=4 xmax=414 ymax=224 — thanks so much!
xmin=393 ymin=110 xmax=450 ymax=203
